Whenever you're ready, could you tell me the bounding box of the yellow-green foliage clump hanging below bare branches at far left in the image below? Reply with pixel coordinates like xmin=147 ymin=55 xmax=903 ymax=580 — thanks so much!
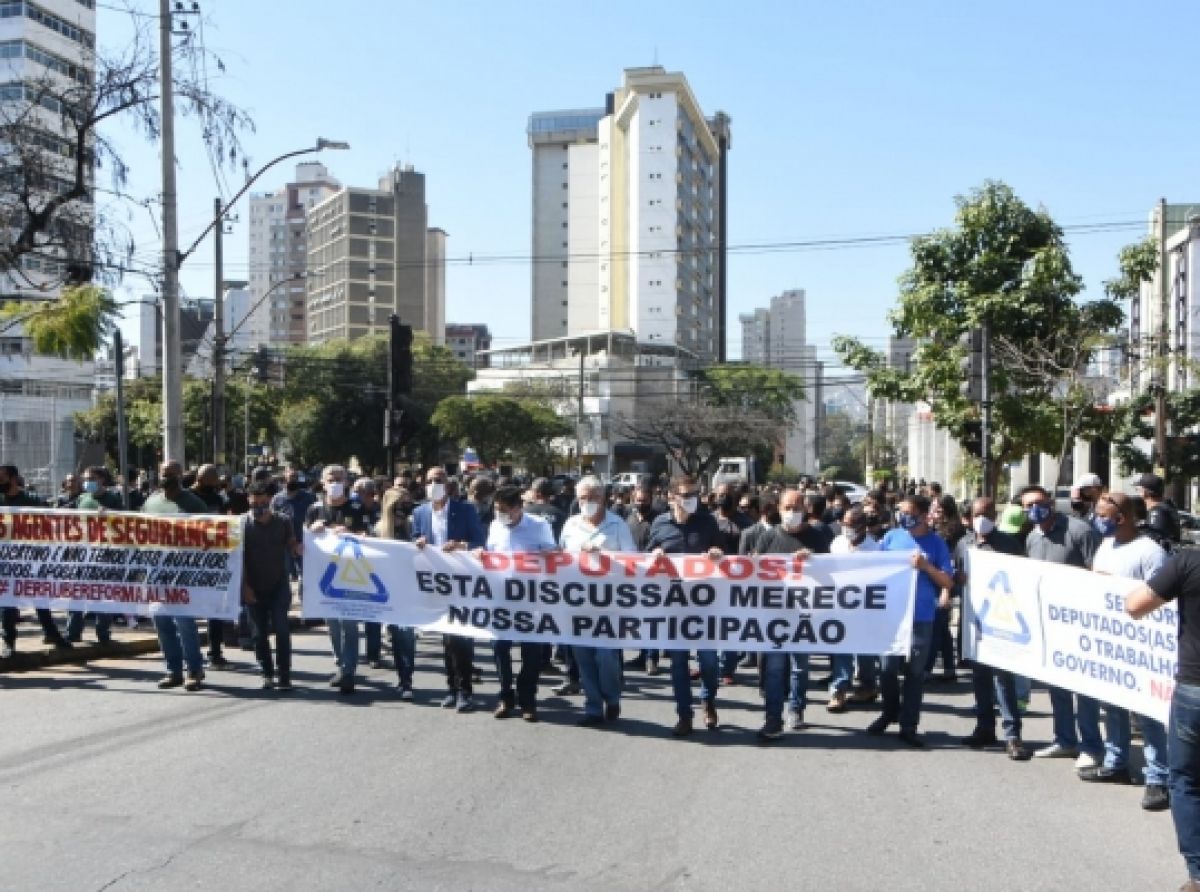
xmin=0 ymin=285 xmax=118 ymax=360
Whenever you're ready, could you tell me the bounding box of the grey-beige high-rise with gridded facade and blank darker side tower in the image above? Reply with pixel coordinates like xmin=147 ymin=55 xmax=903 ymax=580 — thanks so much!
xmin=306 ymin=166 xmax=446 ymax=343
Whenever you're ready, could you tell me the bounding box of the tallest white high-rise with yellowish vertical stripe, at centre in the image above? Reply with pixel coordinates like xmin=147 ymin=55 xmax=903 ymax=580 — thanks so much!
xmin=528 ymin=66 xmax=730 ymax=361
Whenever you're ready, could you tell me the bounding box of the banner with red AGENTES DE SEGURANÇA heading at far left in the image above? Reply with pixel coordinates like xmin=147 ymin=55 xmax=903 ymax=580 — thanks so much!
xmin=0 ymin=508 xmax=242 ymax=619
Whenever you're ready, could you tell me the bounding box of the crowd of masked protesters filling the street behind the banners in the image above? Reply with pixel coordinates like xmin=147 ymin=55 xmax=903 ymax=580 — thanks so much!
xmin=0 ymin=462 xmax=1200 ymax=888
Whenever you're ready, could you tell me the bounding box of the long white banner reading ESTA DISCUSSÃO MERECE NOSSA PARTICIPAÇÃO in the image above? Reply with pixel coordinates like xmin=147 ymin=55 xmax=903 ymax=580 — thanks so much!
xmin=304 ymin=532 xmax=916 ymax=654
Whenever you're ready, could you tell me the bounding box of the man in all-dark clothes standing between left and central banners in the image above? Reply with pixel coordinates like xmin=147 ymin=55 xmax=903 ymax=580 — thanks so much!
xmin=241 ymin=483 xmax=302 ymax=690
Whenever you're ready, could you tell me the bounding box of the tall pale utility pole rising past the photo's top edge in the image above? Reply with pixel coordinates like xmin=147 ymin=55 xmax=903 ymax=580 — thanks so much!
xmin=158 ymin=0 xmax=184 ymax=463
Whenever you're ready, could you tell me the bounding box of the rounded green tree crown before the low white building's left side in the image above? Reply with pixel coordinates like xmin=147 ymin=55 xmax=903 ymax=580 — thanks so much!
xmin=431 ymin=394 xmax=575 ymax=467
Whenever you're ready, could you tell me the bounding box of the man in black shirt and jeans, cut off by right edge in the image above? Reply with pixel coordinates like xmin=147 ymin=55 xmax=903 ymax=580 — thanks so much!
xmin=1126 ymin=540 xmax=1200 ymax=892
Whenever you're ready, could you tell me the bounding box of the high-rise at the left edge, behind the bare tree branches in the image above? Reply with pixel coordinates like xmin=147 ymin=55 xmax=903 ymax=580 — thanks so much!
xmin=0 ymin=0 xmax=96 ymax=495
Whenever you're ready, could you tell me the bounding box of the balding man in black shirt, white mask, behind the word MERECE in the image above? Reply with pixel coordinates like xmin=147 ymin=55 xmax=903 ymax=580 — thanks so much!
xmin=754 ymin=489 xmax=829 ymax=741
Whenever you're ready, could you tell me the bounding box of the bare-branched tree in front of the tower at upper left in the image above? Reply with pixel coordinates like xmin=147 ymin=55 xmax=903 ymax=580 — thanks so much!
xmin=0 ymin=8 xmax=253 ymax=355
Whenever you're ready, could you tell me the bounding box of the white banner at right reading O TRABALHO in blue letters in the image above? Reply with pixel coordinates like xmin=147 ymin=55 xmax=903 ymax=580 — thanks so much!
xmin=962 ymin=549 xmax=1178 ymax=723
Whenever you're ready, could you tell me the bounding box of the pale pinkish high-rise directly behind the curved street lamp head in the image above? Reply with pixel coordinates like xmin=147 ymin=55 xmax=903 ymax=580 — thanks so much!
xmin=246 ymin=161 xmax=341 ymax=346
